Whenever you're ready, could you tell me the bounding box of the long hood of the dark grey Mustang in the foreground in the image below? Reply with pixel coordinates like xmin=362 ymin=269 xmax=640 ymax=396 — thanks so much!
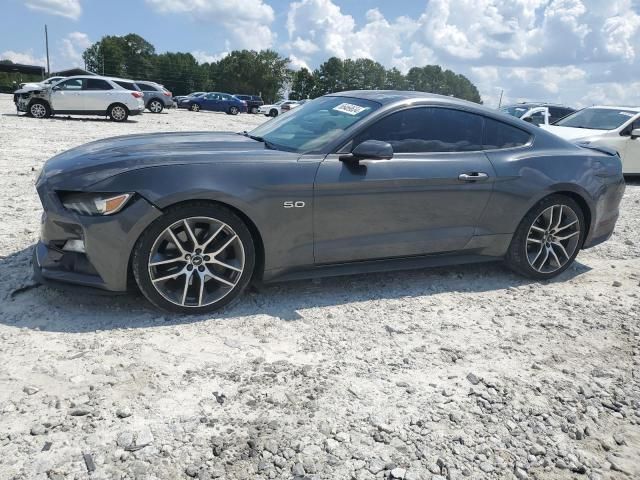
xmin=38 ymin=132 xmax=299 ymax=190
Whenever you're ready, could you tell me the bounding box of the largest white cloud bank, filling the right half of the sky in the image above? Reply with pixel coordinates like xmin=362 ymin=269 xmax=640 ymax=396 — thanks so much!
xmin=283 ymin=0 xmax=640 ymax=106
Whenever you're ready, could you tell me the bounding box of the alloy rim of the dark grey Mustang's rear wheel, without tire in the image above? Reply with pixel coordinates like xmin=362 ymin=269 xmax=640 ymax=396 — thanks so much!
xmin=526 ymin=205 xmax=580 ymax=274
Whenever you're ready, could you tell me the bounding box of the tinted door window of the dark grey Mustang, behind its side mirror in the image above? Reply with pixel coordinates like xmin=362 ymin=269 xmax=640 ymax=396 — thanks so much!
xmin=353 ymin=107 xmax=482 ymax=153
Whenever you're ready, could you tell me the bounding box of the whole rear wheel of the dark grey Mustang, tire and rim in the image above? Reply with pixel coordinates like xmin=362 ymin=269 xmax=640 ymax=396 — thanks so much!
xmin=505 ymin=195 xmax=586 ymax=280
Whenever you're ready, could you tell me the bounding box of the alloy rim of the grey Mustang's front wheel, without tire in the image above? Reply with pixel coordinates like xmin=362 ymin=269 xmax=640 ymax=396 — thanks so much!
xmin=148 ymin=217 xmax=245 ymax=308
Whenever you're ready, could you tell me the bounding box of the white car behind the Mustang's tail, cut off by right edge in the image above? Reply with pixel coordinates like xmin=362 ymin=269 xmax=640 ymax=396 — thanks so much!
xmin=544 ymin=106 xmax=640 ymax=175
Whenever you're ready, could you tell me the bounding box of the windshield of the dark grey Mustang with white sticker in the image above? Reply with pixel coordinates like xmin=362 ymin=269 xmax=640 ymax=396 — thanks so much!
xmin=250 ymin=97 xmax=381 ymax=153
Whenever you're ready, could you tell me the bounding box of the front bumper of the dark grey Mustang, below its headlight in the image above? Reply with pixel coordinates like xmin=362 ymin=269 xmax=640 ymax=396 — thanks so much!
xmin=33 ymin=185 xmax=162 ymax=292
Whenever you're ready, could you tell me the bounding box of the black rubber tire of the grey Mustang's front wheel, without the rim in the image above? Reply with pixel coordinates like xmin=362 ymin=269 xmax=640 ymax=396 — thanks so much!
xmin=132 ymin=201 xmax=256 ymax=314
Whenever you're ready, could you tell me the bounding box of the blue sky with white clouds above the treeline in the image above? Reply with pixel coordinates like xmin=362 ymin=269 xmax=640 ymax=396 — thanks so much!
xmin=0 ymin=0 xmax=640 ymax=107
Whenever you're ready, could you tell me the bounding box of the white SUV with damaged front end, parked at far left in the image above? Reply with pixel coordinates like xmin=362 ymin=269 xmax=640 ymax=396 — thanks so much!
xmin=14 ymin=75 xmax=144 ymax=122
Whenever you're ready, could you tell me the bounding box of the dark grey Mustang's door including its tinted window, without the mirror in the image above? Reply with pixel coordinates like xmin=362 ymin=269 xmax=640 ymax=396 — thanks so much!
xmin=314 ymin=107 xmax=495 ymax=264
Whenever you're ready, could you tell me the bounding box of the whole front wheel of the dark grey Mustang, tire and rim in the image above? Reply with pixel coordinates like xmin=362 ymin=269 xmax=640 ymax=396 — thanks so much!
xmin=132 ymin=202 xmax=255 ymax=314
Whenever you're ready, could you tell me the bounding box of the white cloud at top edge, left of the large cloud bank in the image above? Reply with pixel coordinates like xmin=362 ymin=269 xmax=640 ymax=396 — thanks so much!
xmin=146 ymin=0 xmax=276 ymax=50
